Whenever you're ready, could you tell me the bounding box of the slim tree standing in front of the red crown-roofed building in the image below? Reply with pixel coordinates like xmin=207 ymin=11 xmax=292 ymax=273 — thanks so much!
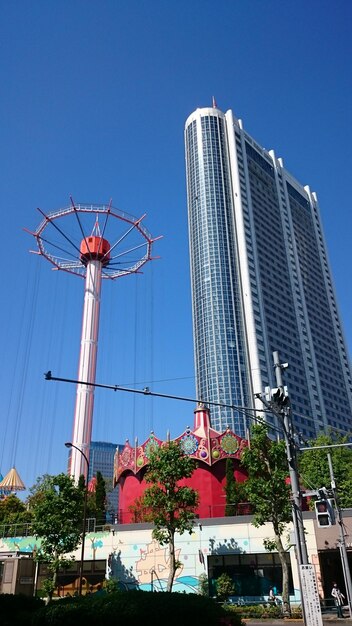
xmin=141 ymin=441 xmax=198 ymax=591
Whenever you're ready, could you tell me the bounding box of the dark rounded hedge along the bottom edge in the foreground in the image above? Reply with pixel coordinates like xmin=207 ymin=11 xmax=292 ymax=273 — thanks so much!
xmin=32 ymin=591 xmax=241 ymax=626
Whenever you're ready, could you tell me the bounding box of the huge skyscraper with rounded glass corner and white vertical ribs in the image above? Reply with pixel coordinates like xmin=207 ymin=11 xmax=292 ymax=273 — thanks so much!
xmin=185 ymin=103 xmax=352 ymax=438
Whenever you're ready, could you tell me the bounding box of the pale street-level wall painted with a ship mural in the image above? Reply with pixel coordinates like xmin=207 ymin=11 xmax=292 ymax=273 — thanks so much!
xmin=0 ymin=518 xmax=320 ymax=602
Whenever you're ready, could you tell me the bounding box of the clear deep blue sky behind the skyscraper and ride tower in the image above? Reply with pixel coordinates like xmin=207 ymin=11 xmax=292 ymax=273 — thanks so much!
xmin=0 ymin=0 xmax=352 ymax=494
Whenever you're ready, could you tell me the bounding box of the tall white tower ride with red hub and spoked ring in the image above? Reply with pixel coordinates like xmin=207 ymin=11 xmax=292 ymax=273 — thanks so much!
xmin=28 ymin=198 xmax=159 ymax=482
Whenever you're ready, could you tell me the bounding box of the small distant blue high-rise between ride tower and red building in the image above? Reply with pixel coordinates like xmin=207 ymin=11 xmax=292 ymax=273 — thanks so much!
xmin=88 ymin=441 xmax=123 ymax=521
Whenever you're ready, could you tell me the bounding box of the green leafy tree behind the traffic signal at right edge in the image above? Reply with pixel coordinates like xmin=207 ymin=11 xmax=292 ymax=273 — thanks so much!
xmin=299 ymin=433 xmax=352 ymax=508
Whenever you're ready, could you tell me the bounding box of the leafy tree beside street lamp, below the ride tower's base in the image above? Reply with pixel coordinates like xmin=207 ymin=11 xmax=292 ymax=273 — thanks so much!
xmin=28 ymin=474 xmax=84 ymax=599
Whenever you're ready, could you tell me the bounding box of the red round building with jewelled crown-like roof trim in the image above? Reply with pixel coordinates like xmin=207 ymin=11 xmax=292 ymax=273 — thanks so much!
xmin=114 ymin=404 xmax=248 ymax=524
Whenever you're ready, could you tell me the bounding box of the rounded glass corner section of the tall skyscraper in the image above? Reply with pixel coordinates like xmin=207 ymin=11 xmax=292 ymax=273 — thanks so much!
xmin=186 ymin=115 xmax=250 ymax=436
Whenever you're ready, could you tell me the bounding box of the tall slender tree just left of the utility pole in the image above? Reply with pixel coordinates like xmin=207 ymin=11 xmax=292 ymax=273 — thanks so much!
xmin=242 ymin=424 xmax=292 ymax=611
